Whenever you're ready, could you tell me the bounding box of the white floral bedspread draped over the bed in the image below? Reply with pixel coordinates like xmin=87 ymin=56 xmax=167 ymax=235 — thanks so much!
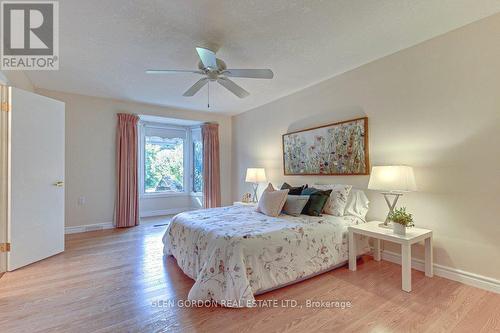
xmin=163 ymin=206 xmax=367 ymax=307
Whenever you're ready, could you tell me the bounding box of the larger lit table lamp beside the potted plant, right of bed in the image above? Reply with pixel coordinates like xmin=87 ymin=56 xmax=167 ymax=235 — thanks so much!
xmin=368 ymin=165 xmax=417 ymax=227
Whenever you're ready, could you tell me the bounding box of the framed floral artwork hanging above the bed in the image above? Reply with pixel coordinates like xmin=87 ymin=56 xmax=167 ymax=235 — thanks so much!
xmin=283 ymin=117 xmax=370 ymax=176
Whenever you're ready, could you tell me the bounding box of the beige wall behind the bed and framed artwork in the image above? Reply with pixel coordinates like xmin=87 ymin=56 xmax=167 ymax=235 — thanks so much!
xmin=232 ymin=15 xmax=500 ymax=279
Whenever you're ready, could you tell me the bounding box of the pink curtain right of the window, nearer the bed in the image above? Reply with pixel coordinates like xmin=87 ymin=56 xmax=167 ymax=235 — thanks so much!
xmin=201 ymin=124 xmax=220 ymax=208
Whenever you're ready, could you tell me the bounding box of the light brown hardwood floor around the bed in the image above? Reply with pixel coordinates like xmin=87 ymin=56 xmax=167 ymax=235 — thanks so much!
xmin=0 ymin=215 xmax=500 ymax=333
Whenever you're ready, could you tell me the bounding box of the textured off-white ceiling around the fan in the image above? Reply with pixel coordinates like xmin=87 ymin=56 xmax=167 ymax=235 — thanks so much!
xmin=27 ymin=0 xmax=500 ymax=114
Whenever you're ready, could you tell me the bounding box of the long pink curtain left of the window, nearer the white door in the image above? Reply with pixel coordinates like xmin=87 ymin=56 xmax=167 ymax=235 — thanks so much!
xmin=115 ymin=113 xmax=139 ymax=228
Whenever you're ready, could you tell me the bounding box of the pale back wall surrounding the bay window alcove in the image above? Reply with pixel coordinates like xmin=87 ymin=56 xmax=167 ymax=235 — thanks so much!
xmin=36 ymin=89 xmax=231 ymax=226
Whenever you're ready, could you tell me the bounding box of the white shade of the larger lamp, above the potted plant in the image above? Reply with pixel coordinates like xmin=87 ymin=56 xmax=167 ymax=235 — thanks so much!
xmin=368 ymin=165 xmax=417 ymax=192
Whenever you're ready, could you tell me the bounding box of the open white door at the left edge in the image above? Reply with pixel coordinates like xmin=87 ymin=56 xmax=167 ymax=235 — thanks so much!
xmin=7 ymin=88 xmax=64 ymax=271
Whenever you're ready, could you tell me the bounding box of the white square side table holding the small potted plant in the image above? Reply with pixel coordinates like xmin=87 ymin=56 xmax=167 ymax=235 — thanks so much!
xmin=349 ymin=221 xmax=433 ymax=292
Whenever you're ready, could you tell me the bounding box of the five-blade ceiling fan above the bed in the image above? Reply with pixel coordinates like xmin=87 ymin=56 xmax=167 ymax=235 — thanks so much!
xmin=146 ymin=47 xmax=274 ymax=98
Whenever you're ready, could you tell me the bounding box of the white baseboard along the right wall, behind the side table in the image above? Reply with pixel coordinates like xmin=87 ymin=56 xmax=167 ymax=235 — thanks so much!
xmin=382 ymin=250 xmax=500 ymax=293
